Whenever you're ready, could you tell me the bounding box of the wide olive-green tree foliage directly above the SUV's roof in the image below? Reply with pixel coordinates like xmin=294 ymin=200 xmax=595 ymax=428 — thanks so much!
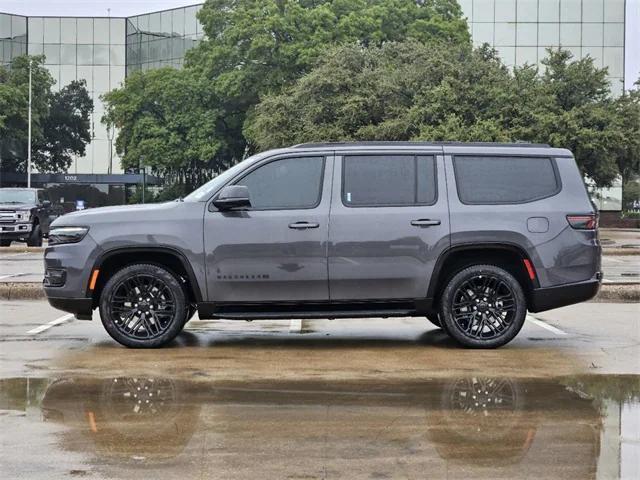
xmin=244 ymin=42 xmax=640 ymax=186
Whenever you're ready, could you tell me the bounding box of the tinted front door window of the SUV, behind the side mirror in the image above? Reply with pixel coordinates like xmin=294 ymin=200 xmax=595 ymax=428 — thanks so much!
xmin=237 ymin=157 xmax=324 ymax=209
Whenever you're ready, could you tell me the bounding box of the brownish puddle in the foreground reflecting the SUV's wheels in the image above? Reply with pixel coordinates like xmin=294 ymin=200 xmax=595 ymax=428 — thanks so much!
xmin=0 ymin=375 xmax=640 ymax=479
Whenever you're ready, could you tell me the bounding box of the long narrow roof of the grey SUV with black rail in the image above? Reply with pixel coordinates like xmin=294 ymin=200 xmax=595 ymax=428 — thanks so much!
xmin=280 ymin=141 xmax=573 ymax=157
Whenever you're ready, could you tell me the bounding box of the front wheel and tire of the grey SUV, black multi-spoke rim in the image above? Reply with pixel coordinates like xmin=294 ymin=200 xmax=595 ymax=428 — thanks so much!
xmin=100 ymin=264 xmax=187 ymax=348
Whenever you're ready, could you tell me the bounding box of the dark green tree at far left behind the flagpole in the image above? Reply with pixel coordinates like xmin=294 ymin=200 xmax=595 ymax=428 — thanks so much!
xmin=0 ymin=56 xmax=93 ymax=172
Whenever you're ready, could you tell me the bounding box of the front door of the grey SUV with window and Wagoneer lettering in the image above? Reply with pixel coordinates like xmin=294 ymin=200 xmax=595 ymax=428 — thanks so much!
xmin=204 ymin=154 xmax=333 ymax=303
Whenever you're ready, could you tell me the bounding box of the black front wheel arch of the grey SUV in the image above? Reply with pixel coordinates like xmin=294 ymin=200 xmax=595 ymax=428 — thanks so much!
xmin=87 ymin=246 xmax=202 ymax=307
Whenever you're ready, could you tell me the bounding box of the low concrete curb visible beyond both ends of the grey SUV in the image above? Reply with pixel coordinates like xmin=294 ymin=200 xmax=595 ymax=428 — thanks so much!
xmin=0 ymin=282 xmax=640 ymax=303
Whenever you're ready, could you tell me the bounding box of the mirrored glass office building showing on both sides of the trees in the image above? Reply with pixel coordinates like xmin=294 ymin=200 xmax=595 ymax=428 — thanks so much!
xmin=0 ymin=0 xmax=625 ymax=180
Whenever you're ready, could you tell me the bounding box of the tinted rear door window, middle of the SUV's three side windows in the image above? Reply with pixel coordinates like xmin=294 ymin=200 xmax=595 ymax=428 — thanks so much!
xmin=342 ymin=155 xmax=436 ymax=206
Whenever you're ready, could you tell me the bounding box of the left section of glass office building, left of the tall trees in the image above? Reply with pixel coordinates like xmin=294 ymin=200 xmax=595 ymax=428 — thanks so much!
xmin=0 ymin=4 xmax=203 ymax=178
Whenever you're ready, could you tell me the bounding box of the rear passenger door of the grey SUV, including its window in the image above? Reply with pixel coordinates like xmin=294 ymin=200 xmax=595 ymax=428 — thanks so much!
xmin=328 ymin=151 xmax=450 ymax=301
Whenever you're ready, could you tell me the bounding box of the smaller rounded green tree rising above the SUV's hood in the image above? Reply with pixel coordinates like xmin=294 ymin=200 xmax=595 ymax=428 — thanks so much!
xmin=103 ymin=67 xmax=229 ymax=186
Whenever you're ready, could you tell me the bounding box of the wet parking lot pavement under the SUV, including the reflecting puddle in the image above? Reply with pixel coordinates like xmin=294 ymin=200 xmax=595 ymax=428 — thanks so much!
xmin=0 ymin=301 xmax=640 ymax=479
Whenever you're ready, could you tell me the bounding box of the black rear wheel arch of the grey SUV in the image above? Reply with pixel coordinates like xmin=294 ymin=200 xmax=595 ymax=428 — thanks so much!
xmin=427 ymin=242 xmax=540 ymax=308
